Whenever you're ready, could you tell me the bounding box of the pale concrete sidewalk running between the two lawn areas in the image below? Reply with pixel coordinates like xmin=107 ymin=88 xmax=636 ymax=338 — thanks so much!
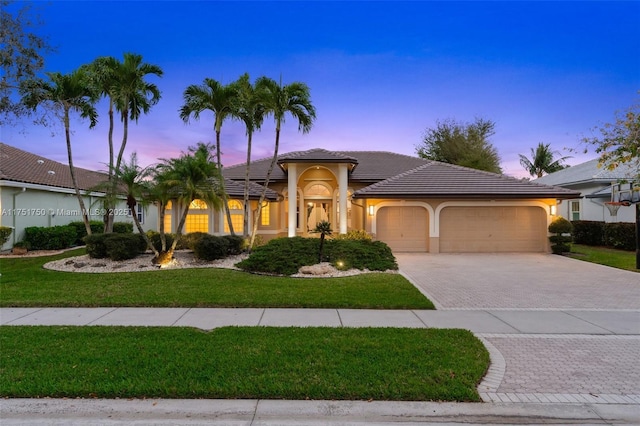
xmin=0 ymin=308 xmax=640 ymax=336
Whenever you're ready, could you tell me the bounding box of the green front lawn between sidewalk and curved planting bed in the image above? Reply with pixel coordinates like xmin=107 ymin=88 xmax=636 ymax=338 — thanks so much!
xmin=0 ymin=249 xmax=433 ymax=309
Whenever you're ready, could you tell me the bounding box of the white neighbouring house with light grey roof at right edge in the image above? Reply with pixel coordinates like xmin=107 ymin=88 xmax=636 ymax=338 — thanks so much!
xmin=532 ymin=159 xmax=638 ymax=222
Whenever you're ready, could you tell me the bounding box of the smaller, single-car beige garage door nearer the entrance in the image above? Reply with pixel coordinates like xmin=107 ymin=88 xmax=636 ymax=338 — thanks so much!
xmin=376 ymin=206 xmax=429 ymax=252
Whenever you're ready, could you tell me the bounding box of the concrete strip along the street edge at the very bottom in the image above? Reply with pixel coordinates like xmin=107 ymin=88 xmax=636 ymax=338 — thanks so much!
xmin=0 ymin=399 xmax=639 ymax=426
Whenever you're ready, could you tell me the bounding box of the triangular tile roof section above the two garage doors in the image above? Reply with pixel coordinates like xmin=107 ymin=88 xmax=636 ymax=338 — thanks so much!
xmin=353 ymin=161 xmax=580 ymax=199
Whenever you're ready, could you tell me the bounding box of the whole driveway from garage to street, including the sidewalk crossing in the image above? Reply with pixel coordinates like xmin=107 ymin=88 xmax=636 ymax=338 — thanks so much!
xmin=396 ymin=253 xmax=640 ymax=404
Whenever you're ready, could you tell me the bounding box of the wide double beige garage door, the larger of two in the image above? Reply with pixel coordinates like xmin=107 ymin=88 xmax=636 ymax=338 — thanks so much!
xmin=440 ymin=206 xmax=547 ymax=253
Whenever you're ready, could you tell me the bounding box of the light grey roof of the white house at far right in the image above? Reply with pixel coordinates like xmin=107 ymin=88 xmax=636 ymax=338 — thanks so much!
xmin=533 ymin=159 xmax=640 ymax=185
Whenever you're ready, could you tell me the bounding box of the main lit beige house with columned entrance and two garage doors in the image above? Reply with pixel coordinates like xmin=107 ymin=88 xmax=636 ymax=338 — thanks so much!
xmin=216 ymin=149 xmax=580 ymax=253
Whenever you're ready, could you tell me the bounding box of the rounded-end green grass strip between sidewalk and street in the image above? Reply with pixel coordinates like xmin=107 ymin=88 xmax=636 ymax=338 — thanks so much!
xmin=0 ymin=326 xmax=489 ymax=401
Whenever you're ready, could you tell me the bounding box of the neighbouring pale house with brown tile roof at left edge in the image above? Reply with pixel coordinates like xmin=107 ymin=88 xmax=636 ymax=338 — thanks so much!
xmin=0 ymin=143 xmax=158 ymax=249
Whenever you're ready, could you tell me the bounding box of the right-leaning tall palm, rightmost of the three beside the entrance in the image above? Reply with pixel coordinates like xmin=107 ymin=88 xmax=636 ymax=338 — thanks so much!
xmin=249 ymin=77 xmax=316 ymax=248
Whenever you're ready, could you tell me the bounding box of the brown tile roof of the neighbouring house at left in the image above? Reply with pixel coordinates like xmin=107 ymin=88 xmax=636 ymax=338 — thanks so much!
xmin=0 ymin=143 xmax=107 ymax=190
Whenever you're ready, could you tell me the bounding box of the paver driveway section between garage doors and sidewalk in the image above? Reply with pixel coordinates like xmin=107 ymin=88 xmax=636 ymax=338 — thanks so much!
xmin=396 ymin=253 xmax=640 ymax=310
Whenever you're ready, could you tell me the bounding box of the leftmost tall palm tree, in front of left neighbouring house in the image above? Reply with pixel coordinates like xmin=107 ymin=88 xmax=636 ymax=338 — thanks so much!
xmin=23 ymin=69 xmax=98 ymax=235
